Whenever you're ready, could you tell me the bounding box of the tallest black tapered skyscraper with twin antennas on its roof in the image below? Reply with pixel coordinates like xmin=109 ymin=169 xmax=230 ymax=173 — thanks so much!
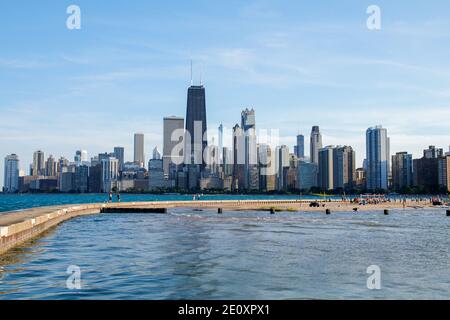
xmin=185 ymin=85 xmax=208 ymax=165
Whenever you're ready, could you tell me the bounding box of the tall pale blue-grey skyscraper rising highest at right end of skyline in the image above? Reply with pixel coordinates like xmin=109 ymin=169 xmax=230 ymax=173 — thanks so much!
xmin=366 ymin=126 xmax=390 ymax=191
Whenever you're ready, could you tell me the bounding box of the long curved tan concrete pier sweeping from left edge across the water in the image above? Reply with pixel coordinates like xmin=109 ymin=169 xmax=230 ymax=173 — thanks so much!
xmin=0 ymin=200 xmax=426 ymax=254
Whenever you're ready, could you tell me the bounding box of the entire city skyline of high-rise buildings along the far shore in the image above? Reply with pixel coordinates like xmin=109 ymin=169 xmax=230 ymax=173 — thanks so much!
xmin=3 ymin=81 xmax=450 ymax=194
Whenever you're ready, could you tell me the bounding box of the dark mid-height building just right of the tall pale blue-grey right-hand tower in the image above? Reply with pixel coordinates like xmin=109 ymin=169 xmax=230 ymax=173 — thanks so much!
xmin=392 ymin=152 xmax=413 ymax=191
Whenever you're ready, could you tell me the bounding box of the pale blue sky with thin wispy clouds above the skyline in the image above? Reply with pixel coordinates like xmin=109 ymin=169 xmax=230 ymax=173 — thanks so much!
xmin=0 ymin=0 xmax=450 ymax=186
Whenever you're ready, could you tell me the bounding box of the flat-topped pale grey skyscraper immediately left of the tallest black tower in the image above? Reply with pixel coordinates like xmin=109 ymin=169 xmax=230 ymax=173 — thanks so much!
xmin=163 ymin=117 xmax=184 ymax=175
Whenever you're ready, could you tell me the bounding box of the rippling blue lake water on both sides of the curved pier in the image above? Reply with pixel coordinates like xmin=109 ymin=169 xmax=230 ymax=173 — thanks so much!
xmin=0 ymin=195 xmax=450 ymax=299
